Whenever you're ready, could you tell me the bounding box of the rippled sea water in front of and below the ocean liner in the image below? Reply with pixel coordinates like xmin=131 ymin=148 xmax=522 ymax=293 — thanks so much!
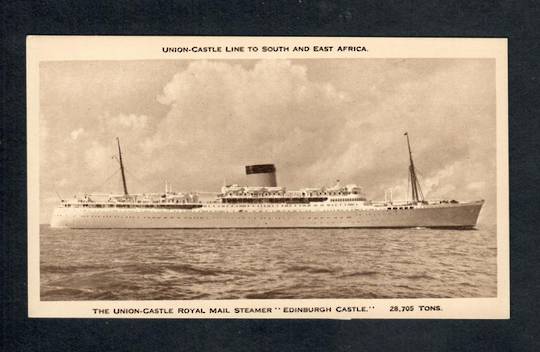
xmin=40 ymin=225 xmax=497 ymax=301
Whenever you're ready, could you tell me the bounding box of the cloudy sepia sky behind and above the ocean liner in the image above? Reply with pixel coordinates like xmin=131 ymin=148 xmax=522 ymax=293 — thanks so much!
xmin=39 ymin=59 xmax=496 ymax=223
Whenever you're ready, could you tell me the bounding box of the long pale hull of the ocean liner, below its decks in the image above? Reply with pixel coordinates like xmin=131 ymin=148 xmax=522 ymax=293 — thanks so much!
xmin=51 ymin=201 xmax=484 ymax=229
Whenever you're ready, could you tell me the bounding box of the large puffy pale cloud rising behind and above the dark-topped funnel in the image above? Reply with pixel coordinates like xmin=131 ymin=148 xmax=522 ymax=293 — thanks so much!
xmin=146 ymin=60 xmax=350 ymax=184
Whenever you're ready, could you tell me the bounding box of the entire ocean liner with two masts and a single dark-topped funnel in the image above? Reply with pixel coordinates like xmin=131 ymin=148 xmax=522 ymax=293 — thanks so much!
xmin=51 ymin=133 xmax=484 ymax=229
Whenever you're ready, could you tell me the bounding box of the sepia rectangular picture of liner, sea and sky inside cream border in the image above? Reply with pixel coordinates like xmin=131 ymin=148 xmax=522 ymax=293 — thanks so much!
xmin=29 ymin=36 xmax=508 ymax=320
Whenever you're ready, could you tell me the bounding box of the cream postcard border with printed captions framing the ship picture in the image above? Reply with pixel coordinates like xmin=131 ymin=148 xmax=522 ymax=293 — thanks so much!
xmin=26 ymin=36 xmax=510 ymax=319
